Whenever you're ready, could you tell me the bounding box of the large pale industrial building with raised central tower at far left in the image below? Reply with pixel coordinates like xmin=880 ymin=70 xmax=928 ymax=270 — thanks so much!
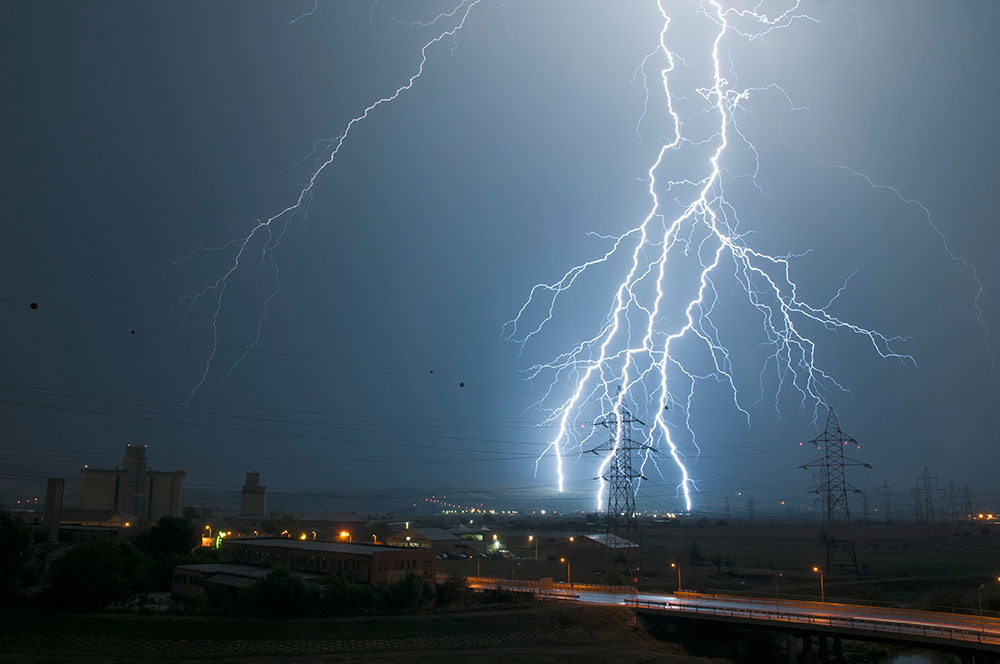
xmin=78 ymin=443 xmax=187 ymax=521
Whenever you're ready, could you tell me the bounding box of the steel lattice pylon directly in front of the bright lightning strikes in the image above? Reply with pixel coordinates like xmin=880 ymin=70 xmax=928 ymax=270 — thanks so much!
xmin=590 ymin=387 xmax=653 ymax=543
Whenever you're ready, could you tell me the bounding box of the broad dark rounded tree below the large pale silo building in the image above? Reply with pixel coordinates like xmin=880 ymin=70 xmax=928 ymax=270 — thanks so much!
xmin=50 ymin=539 xmax=147 ymax=610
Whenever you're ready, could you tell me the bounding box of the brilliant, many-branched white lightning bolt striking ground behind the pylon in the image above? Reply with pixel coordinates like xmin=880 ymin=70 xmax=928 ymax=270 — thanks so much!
xmin=505 ymin=0 xmax=940 ymax=511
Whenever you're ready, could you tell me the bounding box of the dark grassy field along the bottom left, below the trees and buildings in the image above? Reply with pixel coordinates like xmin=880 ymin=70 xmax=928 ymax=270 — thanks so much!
xmin=0 ymin=604 xmax=736 ymax=664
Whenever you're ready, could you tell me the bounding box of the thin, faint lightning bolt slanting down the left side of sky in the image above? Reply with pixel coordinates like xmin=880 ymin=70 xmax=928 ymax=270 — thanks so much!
xmin=171 ymin=0 xmax=482 ymax=405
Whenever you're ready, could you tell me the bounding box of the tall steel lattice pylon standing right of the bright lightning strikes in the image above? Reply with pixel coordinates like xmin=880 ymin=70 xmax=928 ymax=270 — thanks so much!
xmin=802 ymin=409 xmax=871 ymax=572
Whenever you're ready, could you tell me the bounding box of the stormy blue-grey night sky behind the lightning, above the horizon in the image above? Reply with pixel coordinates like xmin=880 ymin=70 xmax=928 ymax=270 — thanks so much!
xmin=0 ymin=0 xmax=1000 ymax=512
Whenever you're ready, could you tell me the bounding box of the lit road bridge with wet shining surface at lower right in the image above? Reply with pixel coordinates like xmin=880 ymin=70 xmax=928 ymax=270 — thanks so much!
xmin=468 ymin=577 xmax=1000 ymax=664
